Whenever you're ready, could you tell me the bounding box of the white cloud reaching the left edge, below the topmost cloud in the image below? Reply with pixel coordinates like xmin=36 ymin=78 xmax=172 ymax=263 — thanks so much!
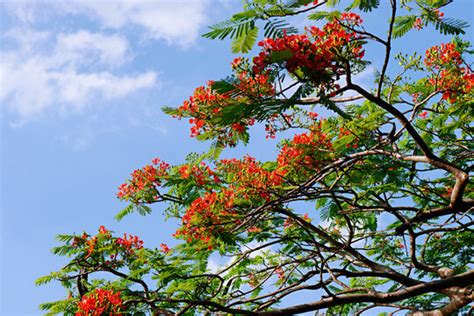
xmin=0 ymin=29 xmax=157 ymax=121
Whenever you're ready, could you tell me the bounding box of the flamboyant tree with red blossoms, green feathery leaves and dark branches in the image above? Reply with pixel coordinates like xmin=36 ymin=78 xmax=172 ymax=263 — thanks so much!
xmin=38 ymin=0 xmax=474 ymax=315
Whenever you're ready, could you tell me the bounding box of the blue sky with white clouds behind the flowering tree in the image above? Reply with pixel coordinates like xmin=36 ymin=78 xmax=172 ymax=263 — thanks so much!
xmin=0 ymin=0 xmax=473 ymax=315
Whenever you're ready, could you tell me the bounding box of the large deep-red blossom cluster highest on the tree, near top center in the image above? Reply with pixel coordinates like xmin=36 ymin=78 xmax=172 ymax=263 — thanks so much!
xmin=253 ymin=13 xmax=364 ymax=92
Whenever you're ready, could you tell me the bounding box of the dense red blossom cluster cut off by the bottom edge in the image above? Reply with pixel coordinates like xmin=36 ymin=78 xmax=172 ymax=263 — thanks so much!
xmin=76 ymin=288 xmax=125 ymax=316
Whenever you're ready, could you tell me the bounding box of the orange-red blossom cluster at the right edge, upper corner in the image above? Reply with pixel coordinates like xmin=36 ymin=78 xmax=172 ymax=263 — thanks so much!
xmin=424 ymin=43 xmax=474 ymax=103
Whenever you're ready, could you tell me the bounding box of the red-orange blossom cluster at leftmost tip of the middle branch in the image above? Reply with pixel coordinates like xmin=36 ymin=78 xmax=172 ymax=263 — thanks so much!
xmin=117 ymin=158 xmax=170 ymax=202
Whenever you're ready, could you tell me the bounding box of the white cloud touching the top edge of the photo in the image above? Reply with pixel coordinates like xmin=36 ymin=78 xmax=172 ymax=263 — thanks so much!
xmin=6 ymin=0 xmax=209 ymax=47
